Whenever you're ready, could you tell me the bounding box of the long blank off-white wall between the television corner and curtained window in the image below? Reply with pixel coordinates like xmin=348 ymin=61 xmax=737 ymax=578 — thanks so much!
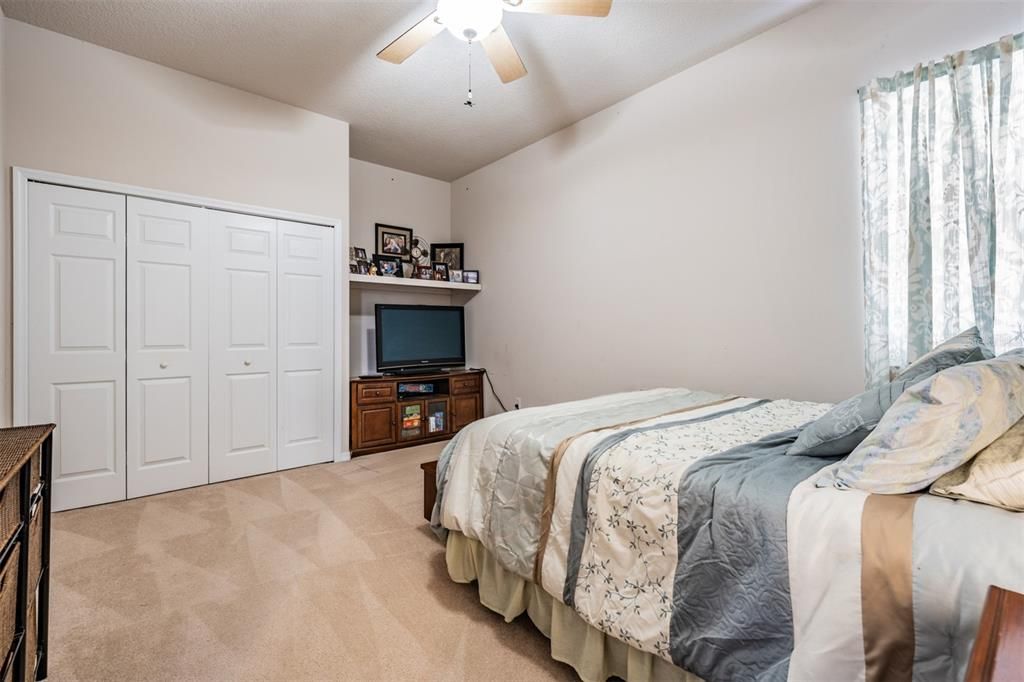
xmin=453 ymin=2 xmax=1024 ymax=406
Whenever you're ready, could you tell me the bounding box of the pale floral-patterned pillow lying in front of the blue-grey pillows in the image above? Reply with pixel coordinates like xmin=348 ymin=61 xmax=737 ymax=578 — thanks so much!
xmin=817 ymin=349 xmax=1024 ymax=495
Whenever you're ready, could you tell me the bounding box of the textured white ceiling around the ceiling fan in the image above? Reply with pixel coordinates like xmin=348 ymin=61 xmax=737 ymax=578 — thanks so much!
xmin=0 ymin=0 xmax=813 ymax=180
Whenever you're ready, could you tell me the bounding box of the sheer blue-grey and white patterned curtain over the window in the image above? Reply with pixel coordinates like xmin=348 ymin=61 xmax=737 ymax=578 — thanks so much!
xmin=860 ymin=34 xmax=1024 ymax=386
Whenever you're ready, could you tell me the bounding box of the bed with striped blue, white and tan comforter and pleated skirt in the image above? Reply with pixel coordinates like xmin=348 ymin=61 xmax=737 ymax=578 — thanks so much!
xmin=431 ymin=389 xmax=1024 ymax=681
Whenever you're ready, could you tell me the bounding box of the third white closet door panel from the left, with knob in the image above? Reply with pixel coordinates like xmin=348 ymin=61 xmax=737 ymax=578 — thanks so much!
xmin=208 ymin=211 xmax=278 ymax=482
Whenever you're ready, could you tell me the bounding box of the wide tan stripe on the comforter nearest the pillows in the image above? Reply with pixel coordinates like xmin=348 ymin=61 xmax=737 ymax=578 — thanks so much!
xmin=860 ymin=495 xmax=921 ymax=682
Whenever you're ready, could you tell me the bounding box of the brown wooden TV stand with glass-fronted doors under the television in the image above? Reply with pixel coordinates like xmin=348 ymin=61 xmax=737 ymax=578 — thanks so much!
xmin=349 ymin=370 xmax=483 ymax=457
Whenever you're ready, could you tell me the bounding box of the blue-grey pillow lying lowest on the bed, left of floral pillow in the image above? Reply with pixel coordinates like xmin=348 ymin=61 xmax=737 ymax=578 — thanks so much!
xmin=785 ymin=380 xmax=915 ymax=457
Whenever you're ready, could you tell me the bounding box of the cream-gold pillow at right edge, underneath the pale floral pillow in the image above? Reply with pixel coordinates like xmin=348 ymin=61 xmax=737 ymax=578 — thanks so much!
xmin=928 ymin=419 xmax=1024 ymax=511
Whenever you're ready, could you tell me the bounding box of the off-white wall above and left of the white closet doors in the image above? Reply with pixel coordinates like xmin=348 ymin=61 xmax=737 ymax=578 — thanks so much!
xmin=0 ymin=19 xmax=348 ymax=423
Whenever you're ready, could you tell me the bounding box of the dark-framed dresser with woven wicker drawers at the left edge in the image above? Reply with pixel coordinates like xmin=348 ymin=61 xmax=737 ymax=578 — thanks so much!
xmin=0 ymin=424 xmax=53 ymax=682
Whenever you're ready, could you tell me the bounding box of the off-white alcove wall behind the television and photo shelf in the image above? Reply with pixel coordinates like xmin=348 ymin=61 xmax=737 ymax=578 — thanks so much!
xmin=349 ymin=159 xmax=452 ymax=376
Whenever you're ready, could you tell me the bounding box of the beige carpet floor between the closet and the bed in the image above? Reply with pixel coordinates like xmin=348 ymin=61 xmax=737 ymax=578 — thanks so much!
xmin=50 ymin=445 xmax=574 ymax=681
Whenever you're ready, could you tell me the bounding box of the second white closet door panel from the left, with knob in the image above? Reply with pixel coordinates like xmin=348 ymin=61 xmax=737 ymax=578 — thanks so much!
xmin=127 ymin=197 xmax=210 ymax=498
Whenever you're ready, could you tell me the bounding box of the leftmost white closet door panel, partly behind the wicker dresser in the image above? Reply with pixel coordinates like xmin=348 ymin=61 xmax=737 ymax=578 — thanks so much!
xmin=28 ymin=182 xmax=125 ymax=511
